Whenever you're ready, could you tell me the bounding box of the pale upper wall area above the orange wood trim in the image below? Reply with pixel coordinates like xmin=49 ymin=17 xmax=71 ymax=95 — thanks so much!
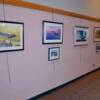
xmin=23 ymin=0 xmax=100 ymax=18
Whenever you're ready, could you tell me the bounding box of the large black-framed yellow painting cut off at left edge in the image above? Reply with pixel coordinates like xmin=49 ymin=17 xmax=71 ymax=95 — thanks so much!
xmin=0 ymin=21 xmax=24 ymax=52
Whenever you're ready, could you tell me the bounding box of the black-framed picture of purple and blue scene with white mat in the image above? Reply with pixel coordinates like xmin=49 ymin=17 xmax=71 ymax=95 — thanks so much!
xmin=42 ymin=21 xmax=63 ymax=44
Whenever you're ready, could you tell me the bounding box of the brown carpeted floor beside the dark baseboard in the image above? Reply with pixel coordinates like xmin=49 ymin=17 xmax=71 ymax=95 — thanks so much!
xmin=32 ymin=70 xmax=100 ymax=100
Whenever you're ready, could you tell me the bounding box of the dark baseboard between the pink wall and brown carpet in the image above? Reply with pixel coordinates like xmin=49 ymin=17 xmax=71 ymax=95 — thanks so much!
xmin=28 ymin=68 xmax=100 ymax=100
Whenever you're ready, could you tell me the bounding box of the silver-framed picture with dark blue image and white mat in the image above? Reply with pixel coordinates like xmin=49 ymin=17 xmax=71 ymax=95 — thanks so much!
xmin=74 ymin=26 xmax=89 ymax=45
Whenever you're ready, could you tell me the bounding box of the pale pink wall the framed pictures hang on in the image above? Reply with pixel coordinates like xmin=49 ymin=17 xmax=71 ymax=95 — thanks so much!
xmin=0 ymin=5 xmax=100 ymax=100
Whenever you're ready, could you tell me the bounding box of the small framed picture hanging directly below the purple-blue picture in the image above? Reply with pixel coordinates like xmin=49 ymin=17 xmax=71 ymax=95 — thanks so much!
xmin=48 ymin=47 xmax=60 ymax=61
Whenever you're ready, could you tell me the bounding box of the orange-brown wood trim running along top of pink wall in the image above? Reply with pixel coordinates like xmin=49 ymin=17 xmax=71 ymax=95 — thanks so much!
xmin=0 ymin=0 xmax=100 ymax=22
